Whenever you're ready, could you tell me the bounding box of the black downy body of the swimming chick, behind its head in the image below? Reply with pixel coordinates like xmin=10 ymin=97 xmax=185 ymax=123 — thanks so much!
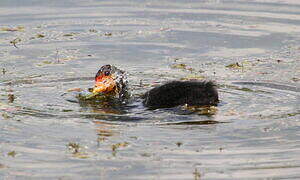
xmin=143 ymin=81 xmax=219 ymax=109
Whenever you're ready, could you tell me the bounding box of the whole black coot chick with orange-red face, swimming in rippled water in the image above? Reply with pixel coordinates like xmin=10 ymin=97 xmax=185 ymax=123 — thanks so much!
xmin=92 ymin=65 xmax=219 ymax=109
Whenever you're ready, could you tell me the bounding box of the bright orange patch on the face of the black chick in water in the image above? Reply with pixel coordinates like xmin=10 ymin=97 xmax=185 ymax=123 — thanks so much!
xmin=93 ymin=76 xmax=117 ymax=93
